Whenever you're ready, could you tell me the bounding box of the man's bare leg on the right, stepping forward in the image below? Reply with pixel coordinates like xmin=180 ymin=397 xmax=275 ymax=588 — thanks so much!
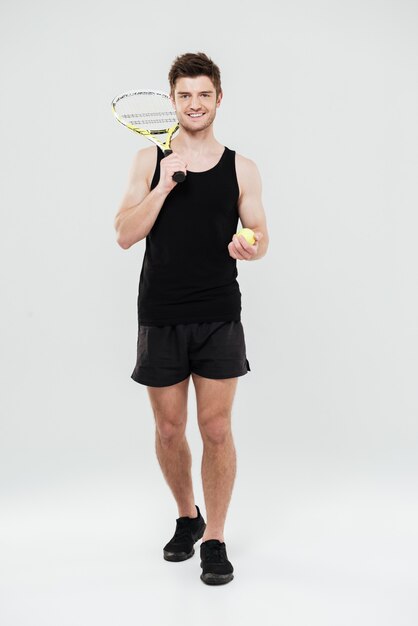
xmin=193 ymin=374 xmax=237 ymax=541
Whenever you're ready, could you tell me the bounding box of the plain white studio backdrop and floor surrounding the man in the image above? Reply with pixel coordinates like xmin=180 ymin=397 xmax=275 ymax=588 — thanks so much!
xmin=0 ymin=0 xmax=418 ymax=626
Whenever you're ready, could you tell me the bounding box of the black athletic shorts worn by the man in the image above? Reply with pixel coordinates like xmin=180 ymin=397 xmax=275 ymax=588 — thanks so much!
xmin=131 ymin=322 xmax=250 ymax=387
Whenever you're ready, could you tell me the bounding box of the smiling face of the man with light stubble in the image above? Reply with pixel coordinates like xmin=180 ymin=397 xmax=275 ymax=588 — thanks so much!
xmin=171 ymin=76 xmax=222 ymax=132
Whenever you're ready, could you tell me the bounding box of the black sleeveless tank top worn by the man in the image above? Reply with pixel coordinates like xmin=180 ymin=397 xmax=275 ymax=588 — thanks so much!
xmin=138 ymin=148 xmax=241 ymax=326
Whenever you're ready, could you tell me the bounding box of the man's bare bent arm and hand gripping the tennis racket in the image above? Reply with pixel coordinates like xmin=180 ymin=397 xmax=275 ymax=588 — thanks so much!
xmin=114 ymin=147 xmax=186 ymax=250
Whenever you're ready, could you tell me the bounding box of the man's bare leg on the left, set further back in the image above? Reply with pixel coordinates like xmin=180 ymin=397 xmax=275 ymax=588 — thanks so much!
xmin=148 ymin=378 xmax=197 ymax=517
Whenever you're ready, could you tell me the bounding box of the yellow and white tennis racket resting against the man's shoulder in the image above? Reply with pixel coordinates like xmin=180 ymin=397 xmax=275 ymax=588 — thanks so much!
xmin=112 ymin=90 xmax=186 ymax=183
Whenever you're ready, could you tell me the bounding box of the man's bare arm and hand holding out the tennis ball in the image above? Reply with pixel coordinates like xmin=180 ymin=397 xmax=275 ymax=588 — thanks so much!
xmin=228 ymin=154 xmax=269 ymax=261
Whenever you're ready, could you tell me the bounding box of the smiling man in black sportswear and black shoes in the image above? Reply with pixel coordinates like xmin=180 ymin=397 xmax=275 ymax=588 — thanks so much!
xmin=115 ymin=53 xmax=268 ymax=585
